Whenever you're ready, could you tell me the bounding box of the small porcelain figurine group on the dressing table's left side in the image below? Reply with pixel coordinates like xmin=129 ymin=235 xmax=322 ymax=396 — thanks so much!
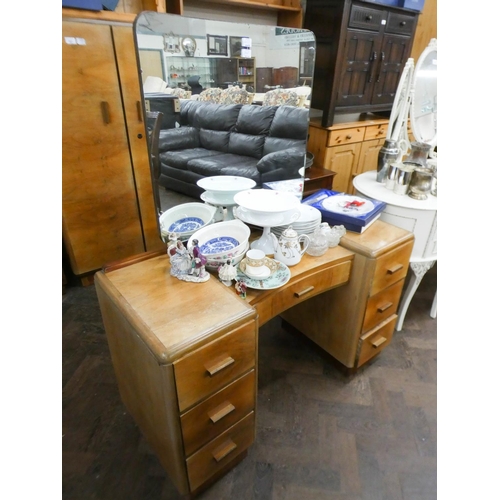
xmin=167 ymin=233 xmax=210 ymax=283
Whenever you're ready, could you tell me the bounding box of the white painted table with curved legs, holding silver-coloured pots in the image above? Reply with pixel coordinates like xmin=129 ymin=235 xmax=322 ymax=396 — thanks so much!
xmin=353 ymin=170 xmax=437 ymax=331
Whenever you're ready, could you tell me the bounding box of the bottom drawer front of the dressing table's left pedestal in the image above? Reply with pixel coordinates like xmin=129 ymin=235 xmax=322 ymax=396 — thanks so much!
xmin=186 ymin=412 xmax=255 ymax=491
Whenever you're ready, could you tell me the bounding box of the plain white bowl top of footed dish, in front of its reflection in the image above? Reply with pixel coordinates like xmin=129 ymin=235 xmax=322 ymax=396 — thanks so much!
xmin=234 ymin=189 xmax=300 ymax=214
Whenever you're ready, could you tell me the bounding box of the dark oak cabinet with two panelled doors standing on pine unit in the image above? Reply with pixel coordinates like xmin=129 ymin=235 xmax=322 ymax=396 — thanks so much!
xmin=304 ymin=0 xmax=418 ymax=127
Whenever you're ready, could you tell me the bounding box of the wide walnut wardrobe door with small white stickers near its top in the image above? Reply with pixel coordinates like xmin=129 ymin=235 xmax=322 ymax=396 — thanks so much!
xmin=62 ymin=21 xmax=145 ymax=275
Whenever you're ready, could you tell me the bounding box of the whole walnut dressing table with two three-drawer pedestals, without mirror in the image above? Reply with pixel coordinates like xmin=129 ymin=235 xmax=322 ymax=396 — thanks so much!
xmin=95 ymin=221 xmax=414 ymax=497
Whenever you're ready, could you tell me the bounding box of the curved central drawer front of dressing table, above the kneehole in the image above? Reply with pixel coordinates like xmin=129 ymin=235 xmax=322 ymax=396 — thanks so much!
xmin=268 ymin=261 xmax=351 ymax=324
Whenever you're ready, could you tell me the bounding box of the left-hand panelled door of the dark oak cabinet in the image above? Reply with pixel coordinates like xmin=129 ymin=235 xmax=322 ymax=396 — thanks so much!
xmin=337 ymin=30 xmax=379 ymax=106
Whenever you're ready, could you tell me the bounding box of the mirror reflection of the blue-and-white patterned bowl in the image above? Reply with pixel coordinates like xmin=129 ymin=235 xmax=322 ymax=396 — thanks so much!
xmin=160 ymin=202 xmax=217 ymax=240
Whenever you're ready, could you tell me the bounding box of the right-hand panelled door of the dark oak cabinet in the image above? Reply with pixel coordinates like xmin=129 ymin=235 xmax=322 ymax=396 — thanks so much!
xmin=372 ymin=35 xmax=411 ymax=104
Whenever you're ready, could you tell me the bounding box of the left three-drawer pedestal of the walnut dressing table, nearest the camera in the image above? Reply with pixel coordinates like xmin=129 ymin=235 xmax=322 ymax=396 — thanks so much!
xmin=95 ymin=256 xmax=258 ymax=495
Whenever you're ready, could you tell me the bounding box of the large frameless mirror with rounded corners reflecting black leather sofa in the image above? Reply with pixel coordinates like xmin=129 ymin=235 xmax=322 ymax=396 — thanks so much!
xmin=134 ymin=12 xmax=315 ymax=215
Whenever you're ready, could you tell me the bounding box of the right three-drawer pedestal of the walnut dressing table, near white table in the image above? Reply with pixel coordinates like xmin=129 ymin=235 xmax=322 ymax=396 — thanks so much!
xmin=282 ymin=221 xmax=414 ymax=368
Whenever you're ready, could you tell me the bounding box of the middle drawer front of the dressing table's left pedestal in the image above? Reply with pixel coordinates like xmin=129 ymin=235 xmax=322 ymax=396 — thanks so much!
xmin=181 ymin=370 xmax=255 ymax=456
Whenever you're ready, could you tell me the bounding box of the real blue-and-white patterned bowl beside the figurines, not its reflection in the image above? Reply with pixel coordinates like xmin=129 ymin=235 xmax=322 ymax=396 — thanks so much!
xmin=187 ymin=220 xmax=250 ymax=260
